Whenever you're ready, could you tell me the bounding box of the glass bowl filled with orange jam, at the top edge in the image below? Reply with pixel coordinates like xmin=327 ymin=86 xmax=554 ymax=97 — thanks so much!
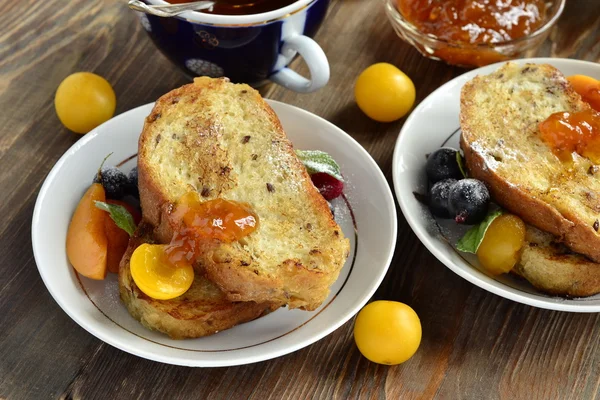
xmin=383 ymin=0 xmax=566 ymax=67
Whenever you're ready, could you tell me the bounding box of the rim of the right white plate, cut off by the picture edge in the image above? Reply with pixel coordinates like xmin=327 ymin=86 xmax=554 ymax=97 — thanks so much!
xmin=392 ymin=57 xmax=600 ymax=313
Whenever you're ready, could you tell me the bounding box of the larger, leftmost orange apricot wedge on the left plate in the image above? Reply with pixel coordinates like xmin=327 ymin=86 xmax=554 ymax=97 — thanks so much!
xmin=67 ymin=183 xmax=110 ymax=280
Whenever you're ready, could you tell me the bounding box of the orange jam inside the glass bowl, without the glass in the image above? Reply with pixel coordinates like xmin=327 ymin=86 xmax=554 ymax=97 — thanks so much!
xmin=397 ymin=0 xmax=546 ymax=44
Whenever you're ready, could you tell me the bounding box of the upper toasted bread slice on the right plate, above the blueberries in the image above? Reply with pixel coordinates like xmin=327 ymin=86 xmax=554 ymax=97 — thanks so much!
xmin=460 ymin=63 xmax=600 ymax=262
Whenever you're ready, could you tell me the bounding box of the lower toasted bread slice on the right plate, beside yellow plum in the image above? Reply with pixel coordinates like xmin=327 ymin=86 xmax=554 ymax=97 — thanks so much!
xmin=513 ymin=226 xmax=600 ymax=297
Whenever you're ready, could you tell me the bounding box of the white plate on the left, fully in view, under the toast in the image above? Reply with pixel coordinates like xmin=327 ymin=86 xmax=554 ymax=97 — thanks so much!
xmin=32 ymin=101 xmax=397 ymax=367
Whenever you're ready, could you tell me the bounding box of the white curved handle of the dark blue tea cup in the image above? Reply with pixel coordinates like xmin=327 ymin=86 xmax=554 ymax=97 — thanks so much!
xmin=269 ymin=35 xmax=329 ymax=93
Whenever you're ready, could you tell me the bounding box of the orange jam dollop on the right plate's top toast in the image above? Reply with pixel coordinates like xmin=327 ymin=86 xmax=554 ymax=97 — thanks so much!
xmin=539 ymin=109 xmax=600 ymax=163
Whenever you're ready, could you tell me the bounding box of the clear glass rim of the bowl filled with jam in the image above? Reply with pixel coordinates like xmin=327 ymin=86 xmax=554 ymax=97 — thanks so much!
xmin=382 ymin=0 xmax=567 ymax=50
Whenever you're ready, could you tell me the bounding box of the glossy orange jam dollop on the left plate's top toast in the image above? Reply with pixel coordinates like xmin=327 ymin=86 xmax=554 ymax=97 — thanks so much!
xmin=166 ymin=192 xmax=258 ymax=266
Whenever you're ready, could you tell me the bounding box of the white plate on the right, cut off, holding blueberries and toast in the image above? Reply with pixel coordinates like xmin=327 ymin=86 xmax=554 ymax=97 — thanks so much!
xmin=393 ymin=58 xmax=600 ymax=312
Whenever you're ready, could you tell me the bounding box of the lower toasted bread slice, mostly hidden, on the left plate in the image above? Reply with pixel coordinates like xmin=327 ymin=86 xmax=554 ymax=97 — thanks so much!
xmin=119 ymin=223 xmax=279 ymax=339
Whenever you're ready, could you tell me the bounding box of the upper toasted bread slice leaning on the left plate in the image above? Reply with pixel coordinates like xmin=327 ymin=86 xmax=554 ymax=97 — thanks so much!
xmin=138 ymin=78 xmax=349 ymax=310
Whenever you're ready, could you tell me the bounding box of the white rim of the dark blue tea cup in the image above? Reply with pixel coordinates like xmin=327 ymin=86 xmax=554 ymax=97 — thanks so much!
xmin=146 ymin=0 xmax=319 ymax=26
